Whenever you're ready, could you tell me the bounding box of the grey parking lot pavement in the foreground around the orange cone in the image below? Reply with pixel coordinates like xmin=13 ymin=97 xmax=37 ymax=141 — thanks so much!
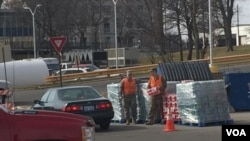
xmin=96 ymin=111 xmax=250 ymax=141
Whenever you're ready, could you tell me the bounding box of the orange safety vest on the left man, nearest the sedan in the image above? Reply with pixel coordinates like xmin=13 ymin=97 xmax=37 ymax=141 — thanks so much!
xmin=123 ymin=78 xmax=136 ymax=95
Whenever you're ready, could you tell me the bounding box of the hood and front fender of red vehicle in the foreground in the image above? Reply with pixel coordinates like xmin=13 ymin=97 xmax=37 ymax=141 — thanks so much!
xmin=0 ymin=105 xmax=95 ymax=141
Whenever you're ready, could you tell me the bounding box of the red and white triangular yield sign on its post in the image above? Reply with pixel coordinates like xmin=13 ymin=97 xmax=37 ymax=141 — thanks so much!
xmin=50 ymin=36 xmax=67 ymax=87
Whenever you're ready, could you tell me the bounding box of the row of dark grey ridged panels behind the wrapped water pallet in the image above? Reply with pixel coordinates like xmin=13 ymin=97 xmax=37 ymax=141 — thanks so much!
xmin=158 ymin=61 xmax=213 ymax=81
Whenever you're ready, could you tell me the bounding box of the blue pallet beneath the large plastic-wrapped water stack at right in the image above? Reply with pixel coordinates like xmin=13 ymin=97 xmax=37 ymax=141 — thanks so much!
xmin=181 ymin=119 xmax=234 ymax=127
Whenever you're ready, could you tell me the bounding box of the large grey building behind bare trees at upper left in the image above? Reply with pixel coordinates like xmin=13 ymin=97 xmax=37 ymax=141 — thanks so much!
xmin=0 ymin=0 xmax=146 ymax=61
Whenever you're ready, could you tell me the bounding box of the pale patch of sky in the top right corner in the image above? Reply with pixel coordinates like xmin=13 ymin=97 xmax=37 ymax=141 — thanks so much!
xmin=232 ymin=0 xmax=250 ymax=25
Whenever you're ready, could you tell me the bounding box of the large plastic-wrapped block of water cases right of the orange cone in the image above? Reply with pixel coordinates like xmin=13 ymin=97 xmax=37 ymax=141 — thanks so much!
xmin=176 ymin=80 xmax=230 ymax=125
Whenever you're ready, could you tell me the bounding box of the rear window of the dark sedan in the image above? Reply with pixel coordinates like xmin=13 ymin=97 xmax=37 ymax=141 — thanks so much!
xmin=58 ymin=87 xmax=102 ymax=101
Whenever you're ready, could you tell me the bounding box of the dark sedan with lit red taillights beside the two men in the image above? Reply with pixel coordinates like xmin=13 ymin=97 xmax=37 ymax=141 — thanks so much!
xmin=32 ymin=86 xmax=114 ymax=129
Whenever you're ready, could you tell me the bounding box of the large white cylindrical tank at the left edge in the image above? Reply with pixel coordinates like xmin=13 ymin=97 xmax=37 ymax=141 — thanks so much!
xmin=0 ymin=59 xmax=49 ymax=88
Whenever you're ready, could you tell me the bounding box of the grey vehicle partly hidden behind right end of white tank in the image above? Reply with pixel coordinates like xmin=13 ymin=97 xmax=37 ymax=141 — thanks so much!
xmin=37 ymin=57 xmax=60 ymax=75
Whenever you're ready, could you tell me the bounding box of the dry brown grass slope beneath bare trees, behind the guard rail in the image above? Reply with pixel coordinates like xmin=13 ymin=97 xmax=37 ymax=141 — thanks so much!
xmin=140 ymin=45 xmax=250 ymax=65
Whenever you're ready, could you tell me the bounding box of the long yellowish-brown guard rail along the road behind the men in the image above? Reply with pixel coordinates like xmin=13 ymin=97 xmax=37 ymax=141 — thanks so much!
xmin=45 ymin=54 xmax=250 ymax=84
